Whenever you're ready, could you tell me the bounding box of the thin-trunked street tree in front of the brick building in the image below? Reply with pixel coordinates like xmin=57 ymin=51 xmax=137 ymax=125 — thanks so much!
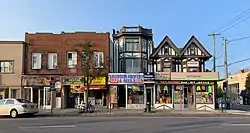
xmin=73 ymin=41 xmax=109 ymax=112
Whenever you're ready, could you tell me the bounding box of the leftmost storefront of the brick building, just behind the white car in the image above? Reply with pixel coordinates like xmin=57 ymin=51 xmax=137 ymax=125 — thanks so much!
xmin=21 ymin=76 xmax=61 ymax=109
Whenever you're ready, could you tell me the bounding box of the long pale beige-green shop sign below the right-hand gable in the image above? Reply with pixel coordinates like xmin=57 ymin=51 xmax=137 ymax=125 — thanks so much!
xmin=171 ymin=72 xmax=219 ymax=81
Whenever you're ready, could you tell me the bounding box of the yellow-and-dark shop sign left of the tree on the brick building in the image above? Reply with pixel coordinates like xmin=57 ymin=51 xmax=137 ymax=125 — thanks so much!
xmin=61 ymin=76 xmax=84 ymax=85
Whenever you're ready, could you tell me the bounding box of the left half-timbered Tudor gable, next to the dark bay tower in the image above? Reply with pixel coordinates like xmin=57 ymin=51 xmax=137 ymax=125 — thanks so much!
xmin=151 ymin=36 xmax=181 ymax=72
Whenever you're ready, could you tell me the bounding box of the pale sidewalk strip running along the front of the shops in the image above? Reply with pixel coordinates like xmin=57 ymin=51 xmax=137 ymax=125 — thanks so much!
xmin=38 ymin=109 xmax=250 ymax=117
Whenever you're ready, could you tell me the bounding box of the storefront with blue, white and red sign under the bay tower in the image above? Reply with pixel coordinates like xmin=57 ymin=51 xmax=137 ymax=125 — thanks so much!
xmin=108 ymin=73 xmax=146 ymax=109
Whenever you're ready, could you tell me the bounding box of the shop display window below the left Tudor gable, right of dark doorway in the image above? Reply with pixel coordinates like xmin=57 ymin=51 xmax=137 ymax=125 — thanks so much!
xmin=156 ymin=85 xmax=172 ymax=104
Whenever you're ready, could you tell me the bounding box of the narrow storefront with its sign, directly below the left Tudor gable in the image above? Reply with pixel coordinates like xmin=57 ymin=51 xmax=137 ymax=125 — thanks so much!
xmin=154 ymin=72 xmax=173 ymax=109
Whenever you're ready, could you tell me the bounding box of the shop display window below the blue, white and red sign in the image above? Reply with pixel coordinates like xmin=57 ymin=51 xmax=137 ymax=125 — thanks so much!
xmin=128 ymin=85 xmax=144 ymax=104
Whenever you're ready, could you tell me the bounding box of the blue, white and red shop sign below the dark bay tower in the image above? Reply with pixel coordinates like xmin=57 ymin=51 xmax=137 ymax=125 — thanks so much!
xmin=108 ymin=73 xmax=144 ymax=84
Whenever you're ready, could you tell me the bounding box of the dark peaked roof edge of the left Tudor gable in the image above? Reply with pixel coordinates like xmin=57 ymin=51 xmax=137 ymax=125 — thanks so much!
xmin=151 ymin=35 xmax=180 ymax=57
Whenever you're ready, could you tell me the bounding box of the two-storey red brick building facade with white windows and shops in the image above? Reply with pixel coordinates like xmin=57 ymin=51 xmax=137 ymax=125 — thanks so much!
xmin=22 ymin=32 xmax=111 ymax=108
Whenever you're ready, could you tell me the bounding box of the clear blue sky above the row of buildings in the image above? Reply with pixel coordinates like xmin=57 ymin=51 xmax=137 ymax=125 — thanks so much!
xmin=0 ymin=0 xmax=250 ymax=77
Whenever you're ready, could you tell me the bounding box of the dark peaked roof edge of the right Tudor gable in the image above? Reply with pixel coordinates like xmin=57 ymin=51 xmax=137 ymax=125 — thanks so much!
xmin=180 ymin=35 xmax=212 ymax=58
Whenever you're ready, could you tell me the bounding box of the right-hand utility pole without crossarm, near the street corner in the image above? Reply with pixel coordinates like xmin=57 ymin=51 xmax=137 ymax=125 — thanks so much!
xmin=223 ymin=38 xmax=231 ymax=97
